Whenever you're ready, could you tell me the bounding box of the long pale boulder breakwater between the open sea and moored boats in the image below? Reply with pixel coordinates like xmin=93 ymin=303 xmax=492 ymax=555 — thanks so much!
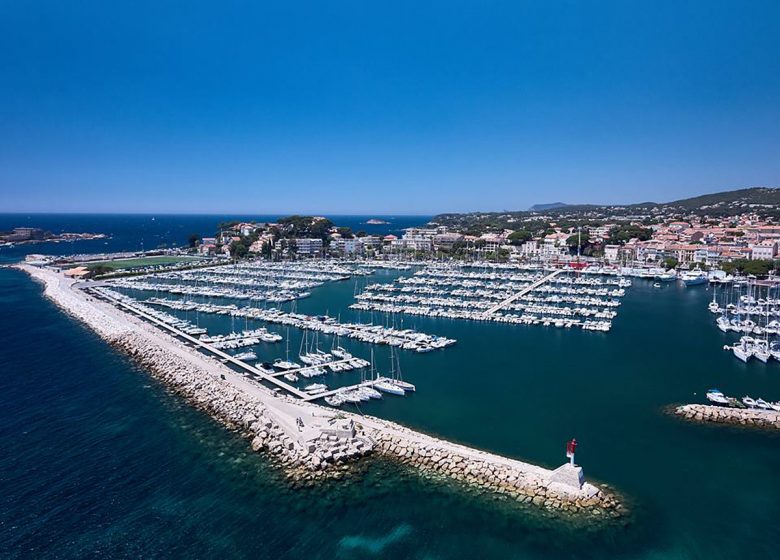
xmin=15 ymin=264 xmax=623 ymax=517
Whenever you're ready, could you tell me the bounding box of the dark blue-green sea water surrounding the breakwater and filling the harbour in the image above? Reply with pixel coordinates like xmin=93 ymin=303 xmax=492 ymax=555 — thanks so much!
xmin=0 ymin=216 xmax=780 ymax=560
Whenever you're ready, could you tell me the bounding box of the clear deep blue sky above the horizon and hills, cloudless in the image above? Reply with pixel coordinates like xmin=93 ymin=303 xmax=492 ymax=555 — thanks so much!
xmin=0 ymin=0 xmax=780 ymax=214
